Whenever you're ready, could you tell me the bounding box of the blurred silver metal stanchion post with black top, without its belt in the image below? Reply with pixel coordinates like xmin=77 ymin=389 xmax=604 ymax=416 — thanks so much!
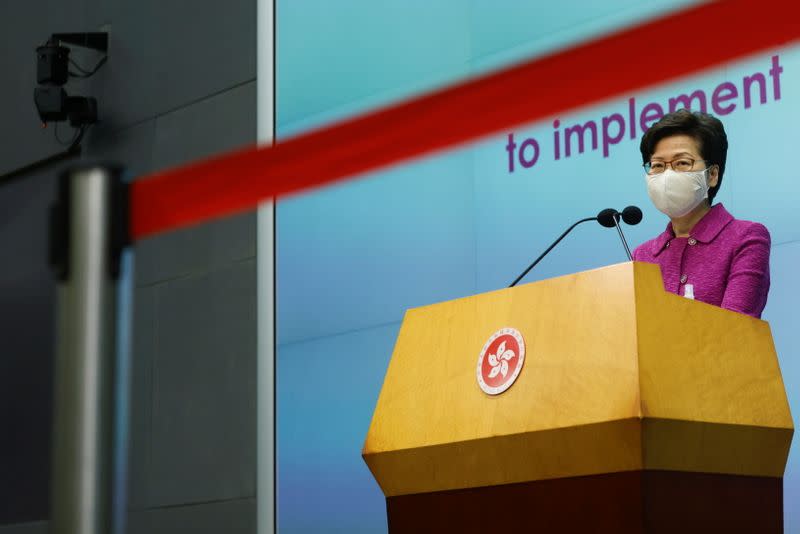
xmin=50 ymin=165 xmax=128 ymax=534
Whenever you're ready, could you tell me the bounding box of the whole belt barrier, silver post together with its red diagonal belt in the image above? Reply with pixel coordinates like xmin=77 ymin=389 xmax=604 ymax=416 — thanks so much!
xmin=51 ymin=0 xmax=800 ymax=534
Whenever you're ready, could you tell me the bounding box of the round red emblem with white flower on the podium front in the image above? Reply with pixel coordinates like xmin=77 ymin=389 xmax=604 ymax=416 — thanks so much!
xmin=477 ymin=328 xmax=525 ymax=395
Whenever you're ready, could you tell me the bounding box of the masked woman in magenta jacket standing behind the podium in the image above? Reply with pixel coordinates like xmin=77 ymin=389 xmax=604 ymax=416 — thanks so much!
xmin=633 ymin=110 xmax=770 ymax=317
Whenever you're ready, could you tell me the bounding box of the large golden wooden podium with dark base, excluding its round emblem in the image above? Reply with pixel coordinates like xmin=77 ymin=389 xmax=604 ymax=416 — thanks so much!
xmin=363 ymin=263 xmax=793 ymax=533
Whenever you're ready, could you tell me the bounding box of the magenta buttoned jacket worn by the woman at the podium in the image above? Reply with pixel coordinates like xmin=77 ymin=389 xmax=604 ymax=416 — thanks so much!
xmin=633 ymin=204 xmax=770 ymax=317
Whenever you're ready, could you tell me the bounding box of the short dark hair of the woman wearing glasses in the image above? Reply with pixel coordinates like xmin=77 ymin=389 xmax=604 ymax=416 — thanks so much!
xmin=639 ymin=109 xmax=728 ymax=204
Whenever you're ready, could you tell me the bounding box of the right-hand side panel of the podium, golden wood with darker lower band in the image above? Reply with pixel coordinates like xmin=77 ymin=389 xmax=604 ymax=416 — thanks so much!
xmin=635 ymin=264 xmax=793 ymax=477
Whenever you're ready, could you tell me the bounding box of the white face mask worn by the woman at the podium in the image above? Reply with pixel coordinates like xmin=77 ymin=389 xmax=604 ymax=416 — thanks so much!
xmin=645 ymin=169 xmax=708 ymax=219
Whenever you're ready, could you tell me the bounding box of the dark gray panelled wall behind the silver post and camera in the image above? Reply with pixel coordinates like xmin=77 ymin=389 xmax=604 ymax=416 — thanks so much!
xmin=0 ymin=0 xmax=256 ymax=534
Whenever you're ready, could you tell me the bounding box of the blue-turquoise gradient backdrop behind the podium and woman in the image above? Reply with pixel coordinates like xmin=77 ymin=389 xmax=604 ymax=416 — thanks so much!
xmin=277 ymin=0 xmax=800 ymax=533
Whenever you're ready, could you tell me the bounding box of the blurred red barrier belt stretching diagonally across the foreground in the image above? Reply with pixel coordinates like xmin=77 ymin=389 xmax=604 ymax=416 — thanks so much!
xmin=131 ymin=0 xmax=800 ymax=239
